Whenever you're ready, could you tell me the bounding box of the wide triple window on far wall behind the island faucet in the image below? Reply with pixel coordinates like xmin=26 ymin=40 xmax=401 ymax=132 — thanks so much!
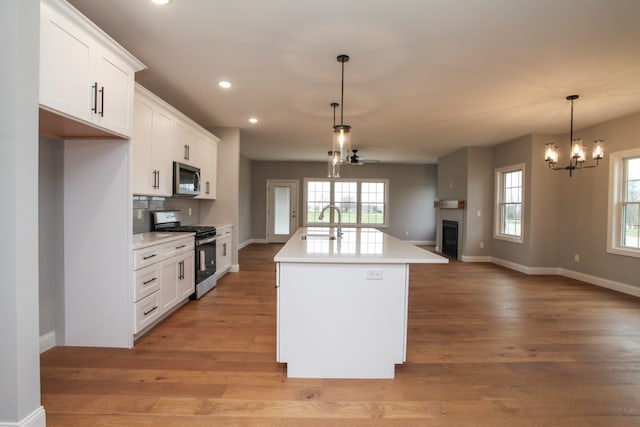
xmin=304 ymin=178 xmax=389 ymax=227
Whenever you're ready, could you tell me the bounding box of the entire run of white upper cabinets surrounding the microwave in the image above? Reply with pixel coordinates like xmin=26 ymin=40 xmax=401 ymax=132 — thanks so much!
xmin=131 ymin=84 xmax=219 ymax=199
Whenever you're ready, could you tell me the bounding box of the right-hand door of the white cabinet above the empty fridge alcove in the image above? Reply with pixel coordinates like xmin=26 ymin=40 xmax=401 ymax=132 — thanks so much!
xmin=95 ymin=46 xmax=134 ymax=136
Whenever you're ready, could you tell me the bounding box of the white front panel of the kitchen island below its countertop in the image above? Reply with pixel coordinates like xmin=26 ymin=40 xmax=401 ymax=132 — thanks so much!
xmin=277 ymin=263 xmax=408 ymax=378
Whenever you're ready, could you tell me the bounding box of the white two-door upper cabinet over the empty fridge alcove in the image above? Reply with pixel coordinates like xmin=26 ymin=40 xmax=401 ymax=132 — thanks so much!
xmin=40 ymin=0 xmax=145 ymax=138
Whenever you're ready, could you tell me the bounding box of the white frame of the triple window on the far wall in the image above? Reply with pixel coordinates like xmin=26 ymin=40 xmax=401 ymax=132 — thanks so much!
xmin=302 ymin=178 xmax=389 ymax=228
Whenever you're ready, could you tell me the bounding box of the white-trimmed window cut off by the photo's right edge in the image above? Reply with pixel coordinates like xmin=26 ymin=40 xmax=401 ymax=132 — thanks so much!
xmin=607 ymin=149 xmax=640 ymax=257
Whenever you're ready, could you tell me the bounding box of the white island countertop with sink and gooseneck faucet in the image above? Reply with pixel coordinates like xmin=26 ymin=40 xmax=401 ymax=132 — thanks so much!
xmin=274 ymin=227 xmax=449 ymax=264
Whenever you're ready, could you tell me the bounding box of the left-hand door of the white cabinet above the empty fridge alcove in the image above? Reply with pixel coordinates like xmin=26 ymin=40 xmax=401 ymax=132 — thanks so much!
xmin=40 ymin=4 xmax=96 ymax=122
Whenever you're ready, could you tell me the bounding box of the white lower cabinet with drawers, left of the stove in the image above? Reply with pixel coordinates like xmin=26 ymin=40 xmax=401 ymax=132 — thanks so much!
xmin=133 ymin=237 xmax=195 ymax=334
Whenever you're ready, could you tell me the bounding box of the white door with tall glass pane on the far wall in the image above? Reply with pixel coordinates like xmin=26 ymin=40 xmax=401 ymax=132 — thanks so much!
xmin=267 ymin=180 xmax=298 ymax=243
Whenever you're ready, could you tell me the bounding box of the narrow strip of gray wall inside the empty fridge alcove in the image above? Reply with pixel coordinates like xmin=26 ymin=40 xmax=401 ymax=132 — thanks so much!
xmin=38 ymin=136 xmax=65 ymax=343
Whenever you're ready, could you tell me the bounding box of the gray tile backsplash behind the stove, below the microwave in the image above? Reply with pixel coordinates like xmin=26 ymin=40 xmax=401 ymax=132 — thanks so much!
xmin=133 ymin=196 xmax=200 ymax=234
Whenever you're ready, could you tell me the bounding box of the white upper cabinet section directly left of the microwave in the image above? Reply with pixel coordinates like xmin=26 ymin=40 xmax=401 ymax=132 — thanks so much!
xmin=131 ymin=86 xmax=173 ymax=197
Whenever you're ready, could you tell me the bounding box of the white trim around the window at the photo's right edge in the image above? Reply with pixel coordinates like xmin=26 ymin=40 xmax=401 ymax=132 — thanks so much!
xmin=607 ymin=148 xmax=640 ymax=258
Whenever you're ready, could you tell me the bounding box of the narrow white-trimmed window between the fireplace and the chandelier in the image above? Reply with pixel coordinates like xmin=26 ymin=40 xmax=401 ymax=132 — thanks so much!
xmin=494 ymin=164 xmax=524 ymax=243
